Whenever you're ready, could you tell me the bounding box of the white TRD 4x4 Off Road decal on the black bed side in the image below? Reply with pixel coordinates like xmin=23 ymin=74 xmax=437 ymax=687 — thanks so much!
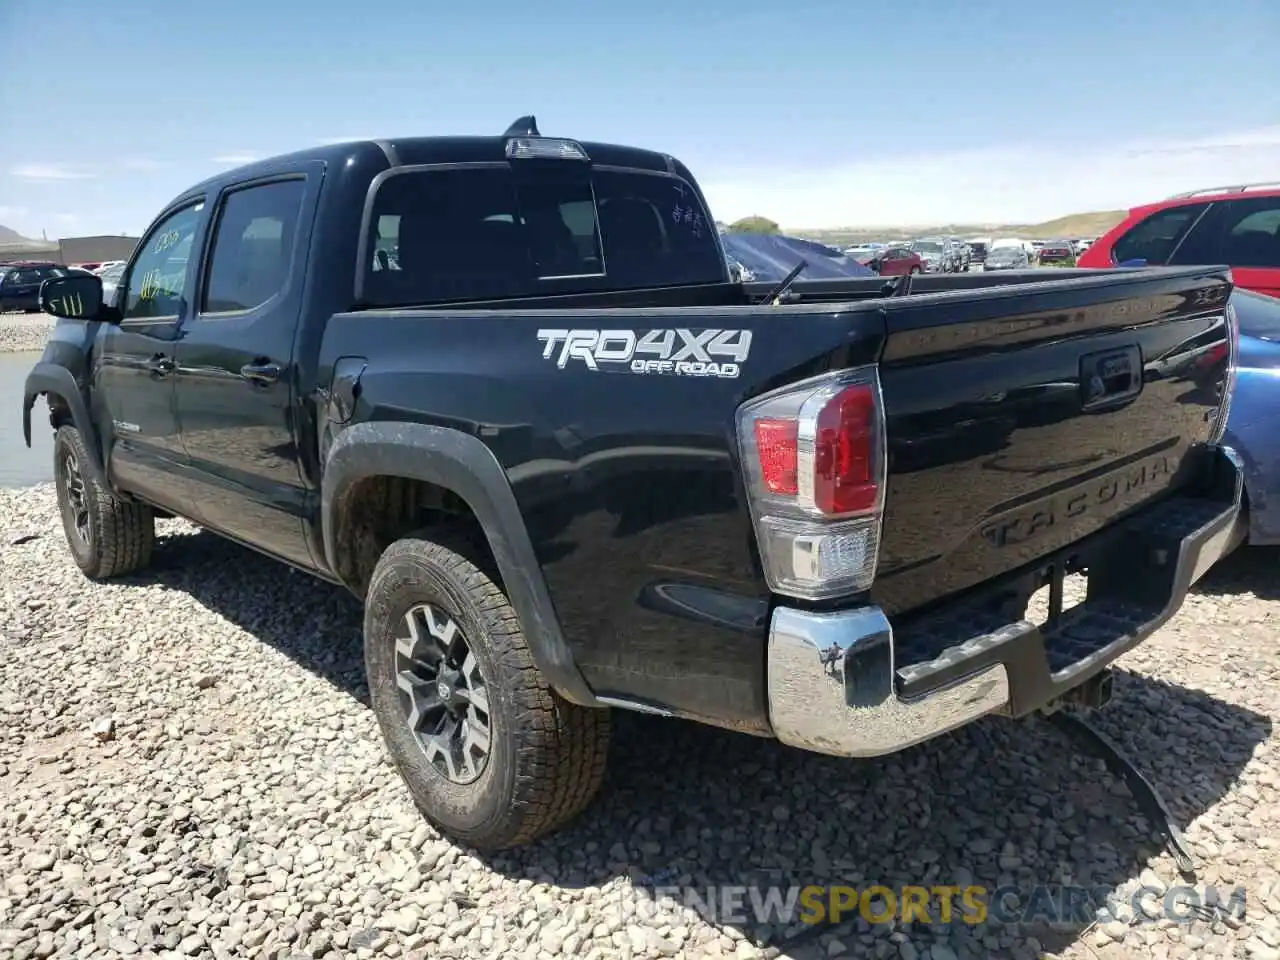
xmin=538 ymin=329 xmax=751 ymax=378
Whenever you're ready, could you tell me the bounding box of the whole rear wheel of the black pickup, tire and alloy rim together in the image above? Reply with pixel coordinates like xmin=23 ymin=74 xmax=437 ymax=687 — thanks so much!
xmin=365 ymin=531 xmax=609 ymax=850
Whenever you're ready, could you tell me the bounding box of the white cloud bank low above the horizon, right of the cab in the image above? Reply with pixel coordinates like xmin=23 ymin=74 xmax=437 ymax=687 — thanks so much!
xmin=700 ymin=127 xmax=1280 ymax=229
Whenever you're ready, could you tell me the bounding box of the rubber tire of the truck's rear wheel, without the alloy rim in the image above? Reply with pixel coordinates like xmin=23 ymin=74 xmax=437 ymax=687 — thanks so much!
xmin=365 ymin=529 xmax=609 ymax=850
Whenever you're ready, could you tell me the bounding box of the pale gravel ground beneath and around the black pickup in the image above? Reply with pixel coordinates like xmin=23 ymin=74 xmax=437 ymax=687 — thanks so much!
xmin=0 ymin=485 xmax=1280 ymax=960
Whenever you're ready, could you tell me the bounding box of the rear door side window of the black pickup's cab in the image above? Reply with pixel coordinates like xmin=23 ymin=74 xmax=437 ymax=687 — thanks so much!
xmin=200 ymin=180 xmax=306 ymax=314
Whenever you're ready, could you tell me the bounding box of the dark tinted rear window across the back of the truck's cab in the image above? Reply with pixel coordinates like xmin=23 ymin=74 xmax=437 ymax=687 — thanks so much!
xmin=362 ymin=165 xmax=726 ymax=306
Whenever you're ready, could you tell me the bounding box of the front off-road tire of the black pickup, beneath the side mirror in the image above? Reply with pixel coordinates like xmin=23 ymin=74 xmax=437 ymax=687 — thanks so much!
xmin=54 ymin=426 xmax=156 ymax=580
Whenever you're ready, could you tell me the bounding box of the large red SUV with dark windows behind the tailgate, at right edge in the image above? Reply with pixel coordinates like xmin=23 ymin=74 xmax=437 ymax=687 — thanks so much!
xmin=1078 ymin=183 xmax=1280 ymax=297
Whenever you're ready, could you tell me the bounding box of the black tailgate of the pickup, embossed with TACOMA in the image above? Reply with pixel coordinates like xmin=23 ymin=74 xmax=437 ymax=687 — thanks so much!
xmin=873 ymin=268 xmax=1231 ymax=613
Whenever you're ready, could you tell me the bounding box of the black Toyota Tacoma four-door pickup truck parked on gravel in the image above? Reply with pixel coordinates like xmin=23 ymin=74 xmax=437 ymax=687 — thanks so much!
xmin=23 ymin=118 xmax=1242 ymax=849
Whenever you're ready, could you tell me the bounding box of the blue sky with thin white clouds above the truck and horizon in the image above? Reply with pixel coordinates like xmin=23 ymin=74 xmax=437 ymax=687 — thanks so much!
xmin=0 ymin=0 xmax=1280 ymax=239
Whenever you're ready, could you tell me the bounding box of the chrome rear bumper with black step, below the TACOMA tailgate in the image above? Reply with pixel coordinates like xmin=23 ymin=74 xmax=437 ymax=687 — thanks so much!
xmin=767 ymin=448 xmax=1245 ymax=756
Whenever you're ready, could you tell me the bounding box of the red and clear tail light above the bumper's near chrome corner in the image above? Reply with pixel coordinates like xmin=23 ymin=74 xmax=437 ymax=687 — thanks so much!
xmin=737 ymin=366 xmax=886 ymax=600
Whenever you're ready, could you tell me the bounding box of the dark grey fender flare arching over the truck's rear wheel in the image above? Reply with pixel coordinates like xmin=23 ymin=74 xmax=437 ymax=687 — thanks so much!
xmin=320 ymin=421 xmax=599 ymax=707
